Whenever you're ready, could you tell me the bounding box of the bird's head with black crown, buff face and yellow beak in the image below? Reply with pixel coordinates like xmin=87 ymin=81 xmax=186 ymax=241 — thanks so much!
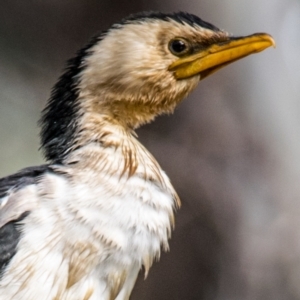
xmin=42 ymin=12 xmax=274 ymax=163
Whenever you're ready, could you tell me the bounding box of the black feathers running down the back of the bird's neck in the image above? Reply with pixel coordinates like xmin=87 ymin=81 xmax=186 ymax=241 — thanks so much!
xmin=39 ymin=36 xmax=101 ymax=163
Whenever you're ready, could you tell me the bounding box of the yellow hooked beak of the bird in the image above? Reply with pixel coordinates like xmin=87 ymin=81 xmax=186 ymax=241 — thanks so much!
xmin=169 ymin=33 xmax=275 ymax=80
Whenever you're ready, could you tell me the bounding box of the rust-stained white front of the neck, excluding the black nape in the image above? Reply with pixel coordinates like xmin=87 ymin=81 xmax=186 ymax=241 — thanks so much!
xmin=64 ymin=113 xmax=180 ymax=206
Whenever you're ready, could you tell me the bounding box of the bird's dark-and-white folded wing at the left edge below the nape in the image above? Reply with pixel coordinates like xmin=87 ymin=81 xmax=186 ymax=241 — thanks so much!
xmin=0 ymin=165 xmax=50 ymax=277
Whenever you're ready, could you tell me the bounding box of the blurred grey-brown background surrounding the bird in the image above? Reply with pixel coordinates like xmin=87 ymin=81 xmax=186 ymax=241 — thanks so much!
xmin=0 ymin=0 xmax=300 ymax=300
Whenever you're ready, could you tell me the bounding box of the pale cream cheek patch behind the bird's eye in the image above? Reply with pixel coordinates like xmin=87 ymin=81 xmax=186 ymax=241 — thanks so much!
xmin=81 ymin=23 xmax=174 ymax=89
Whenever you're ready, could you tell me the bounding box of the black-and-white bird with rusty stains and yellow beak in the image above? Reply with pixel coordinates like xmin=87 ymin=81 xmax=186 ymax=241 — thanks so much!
xmin=0 ymin=11 xmax=275 ymax=300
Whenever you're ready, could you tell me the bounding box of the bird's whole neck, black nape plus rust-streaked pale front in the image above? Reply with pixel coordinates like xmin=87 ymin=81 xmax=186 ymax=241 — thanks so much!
xmin=42 ymin=86 xmax=180 ymax=206
